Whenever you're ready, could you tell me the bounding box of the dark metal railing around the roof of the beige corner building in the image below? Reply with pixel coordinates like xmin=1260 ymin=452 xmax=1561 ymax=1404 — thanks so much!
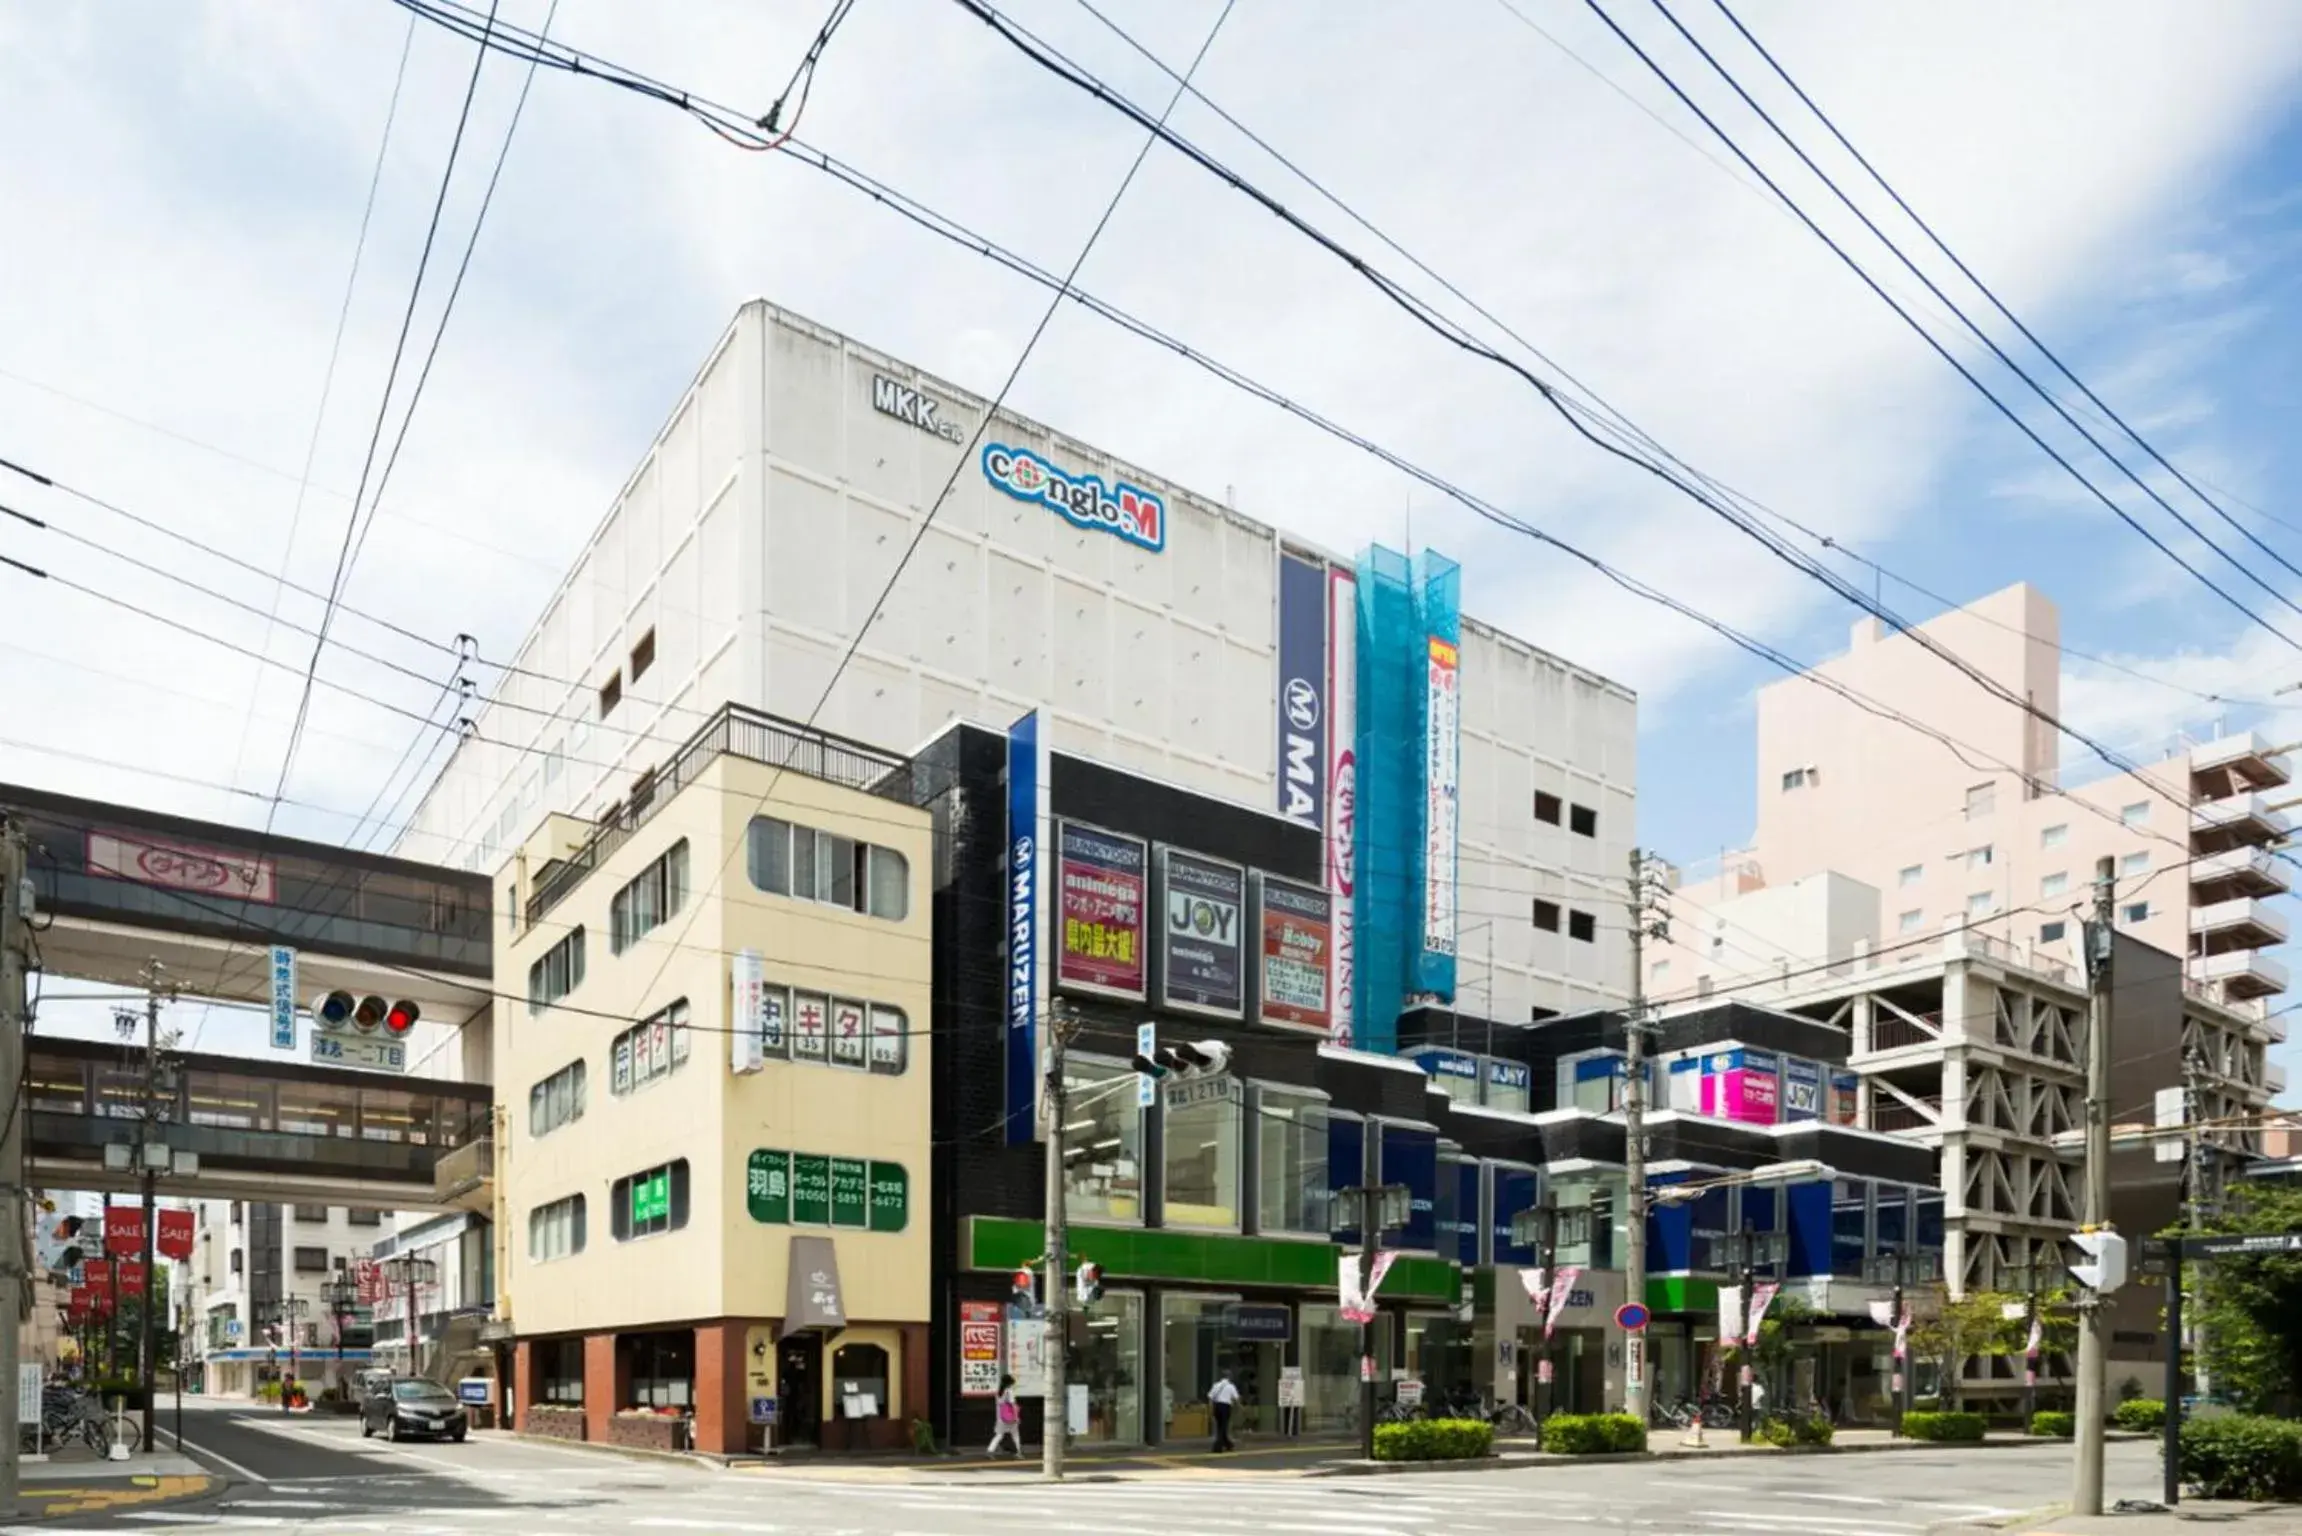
xmin=525 ymin=705 xmax=916 ymax=923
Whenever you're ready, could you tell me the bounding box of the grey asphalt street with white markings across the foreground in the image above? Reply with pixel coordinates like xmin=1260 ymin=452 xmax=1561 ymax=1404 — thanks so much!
xmin=12 ymin=1405 xmax=2157 ymax=1536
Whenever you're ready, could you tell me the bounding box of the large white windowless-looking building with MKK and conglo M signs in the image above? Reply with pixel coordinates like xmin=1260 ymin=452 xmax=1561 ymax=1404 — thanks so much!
xmin=398 ymin=302 xmax=1637 ymax=1018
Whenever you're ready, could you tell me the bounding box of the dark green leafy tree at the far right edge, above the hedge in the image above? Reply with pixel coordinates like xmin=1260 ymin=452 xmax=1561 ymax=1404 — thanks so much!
xmin=2185 ymin=1184 xmax=2302 ymax=1412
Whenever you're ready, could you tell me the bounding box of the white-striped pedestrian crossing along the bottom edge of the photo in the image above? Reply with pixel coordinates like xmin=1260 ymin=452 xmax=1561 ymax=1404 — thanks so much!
xmin=4 ymin=1467 xmax=2014 ymax=1536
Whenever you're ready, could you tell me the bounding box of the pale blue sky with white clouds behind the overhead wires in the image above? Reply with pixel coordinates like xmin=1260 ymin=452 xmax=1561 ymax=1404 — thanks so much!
xmin=0 ymin=0 xmax=2302 ymax=1091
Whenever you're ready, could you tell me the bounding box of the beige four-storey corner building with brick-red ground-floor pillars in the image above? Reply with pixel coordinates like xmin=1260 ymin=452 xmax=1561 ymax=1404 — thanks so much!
xmin=495 ymin=707 xmax=930 ymax=1451
